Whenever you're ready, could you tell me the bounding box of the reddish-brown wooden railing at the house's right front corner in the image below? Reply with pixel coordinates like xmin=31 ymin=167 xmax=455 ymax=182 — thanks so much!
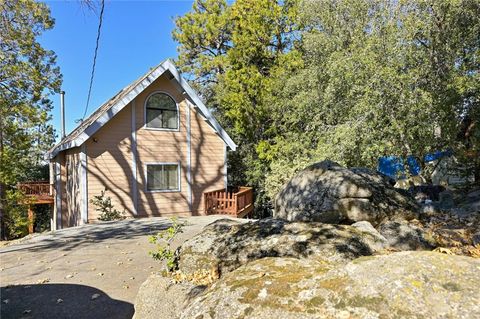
xmin=203 ymin=186 xmax=253 ymax=218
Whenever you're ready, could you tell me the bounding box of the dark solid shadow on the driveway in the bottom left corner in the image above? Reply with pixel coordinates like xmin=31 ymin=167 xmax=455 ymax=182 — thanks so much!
xmin=0 ymin=284 xmax=134 ymax=319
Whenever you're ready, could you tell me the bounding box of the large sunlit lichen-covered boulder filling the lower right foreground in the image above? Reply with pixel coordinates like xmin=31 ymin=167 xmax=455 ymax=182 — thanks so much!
xmin=180 ymin=251 xmax=480 ymax=319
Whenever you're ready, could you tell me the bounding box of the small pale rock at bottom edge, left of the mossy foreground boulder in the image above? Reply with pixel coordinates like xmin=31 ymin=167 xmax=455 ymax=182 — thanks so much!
xmin=133 ymin=274 xmax=205 ymax=319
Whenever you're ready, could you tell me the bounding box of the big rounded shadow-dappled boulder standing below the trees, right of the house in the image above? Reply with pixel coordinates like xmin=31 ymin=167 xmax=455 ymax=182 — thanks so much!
xmin=274 ymin=161 xmax=418 ymax=227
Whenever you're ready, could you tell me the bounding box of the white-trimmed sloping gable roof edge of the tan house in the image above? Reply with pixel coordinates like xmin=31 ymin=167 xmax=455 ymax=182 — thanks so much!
xmin=45 ymin=59 xmax=237 ymax=159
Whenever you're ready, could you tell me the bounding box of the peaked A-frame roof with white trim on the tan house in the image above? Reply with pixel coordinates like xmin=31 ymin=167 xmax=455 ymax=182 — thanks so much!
xmin=47 ymin=59 xmax=237 ymax=159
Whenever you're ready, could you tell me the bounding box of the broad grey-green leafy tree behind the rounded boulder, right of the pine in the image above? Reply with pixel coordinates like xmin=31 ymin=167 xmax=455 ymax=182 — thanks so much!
xmin=257 ymin=0 xmax=480 ymax=197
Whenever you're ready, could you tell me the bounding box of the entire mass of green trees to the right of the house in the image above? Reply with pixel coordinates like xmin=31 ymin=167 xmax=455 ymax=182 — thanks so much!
xmin=173 ymin=0 xmax=480 ymax=217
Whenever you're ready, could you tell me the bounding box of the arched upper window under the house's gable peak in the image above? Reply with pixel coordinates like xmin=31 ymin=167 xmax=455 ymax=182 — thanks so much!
xmin=145 ymin=93 xmax=178 ymax=129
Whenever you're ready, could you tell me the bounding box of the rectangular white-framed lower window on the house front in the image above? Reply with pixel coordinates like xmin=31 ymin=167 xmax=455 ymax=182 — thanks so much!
xmin=147 ymin=164 xmax=180 ymax=191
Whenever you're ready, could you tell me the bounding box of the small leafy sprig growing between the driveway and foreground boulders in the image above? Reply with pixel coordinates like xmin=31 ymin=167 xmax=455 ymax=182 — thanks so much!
xmin=148 ymin=217 xmax=185 ymax=272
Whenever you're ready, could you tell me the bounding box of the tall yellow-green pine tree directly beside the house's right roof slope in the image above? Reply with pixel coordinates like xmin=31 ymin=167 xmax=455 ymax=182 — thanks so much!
xmin=173 ymin=0 xmax=301 ymax=216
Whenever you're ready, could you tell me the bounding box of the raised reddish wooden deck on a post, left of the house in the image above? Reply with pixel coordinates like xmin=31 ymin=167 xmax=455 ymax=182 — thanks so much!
xmin=17 ymin=181 xmax=53 ymax=234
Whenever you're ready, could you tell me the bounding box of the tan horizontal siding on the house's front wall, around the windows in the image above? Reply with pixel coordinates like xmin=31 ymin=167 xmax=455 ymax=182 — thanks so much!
xmin=55 ymin=72 xmax=225 ymax=226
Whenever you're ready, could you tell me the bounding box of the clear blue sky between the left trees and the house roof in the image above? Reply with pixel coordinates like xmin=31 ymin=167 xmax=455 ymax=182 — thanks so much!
xmin=39 ymin=0 xmax=192 ymax=140
